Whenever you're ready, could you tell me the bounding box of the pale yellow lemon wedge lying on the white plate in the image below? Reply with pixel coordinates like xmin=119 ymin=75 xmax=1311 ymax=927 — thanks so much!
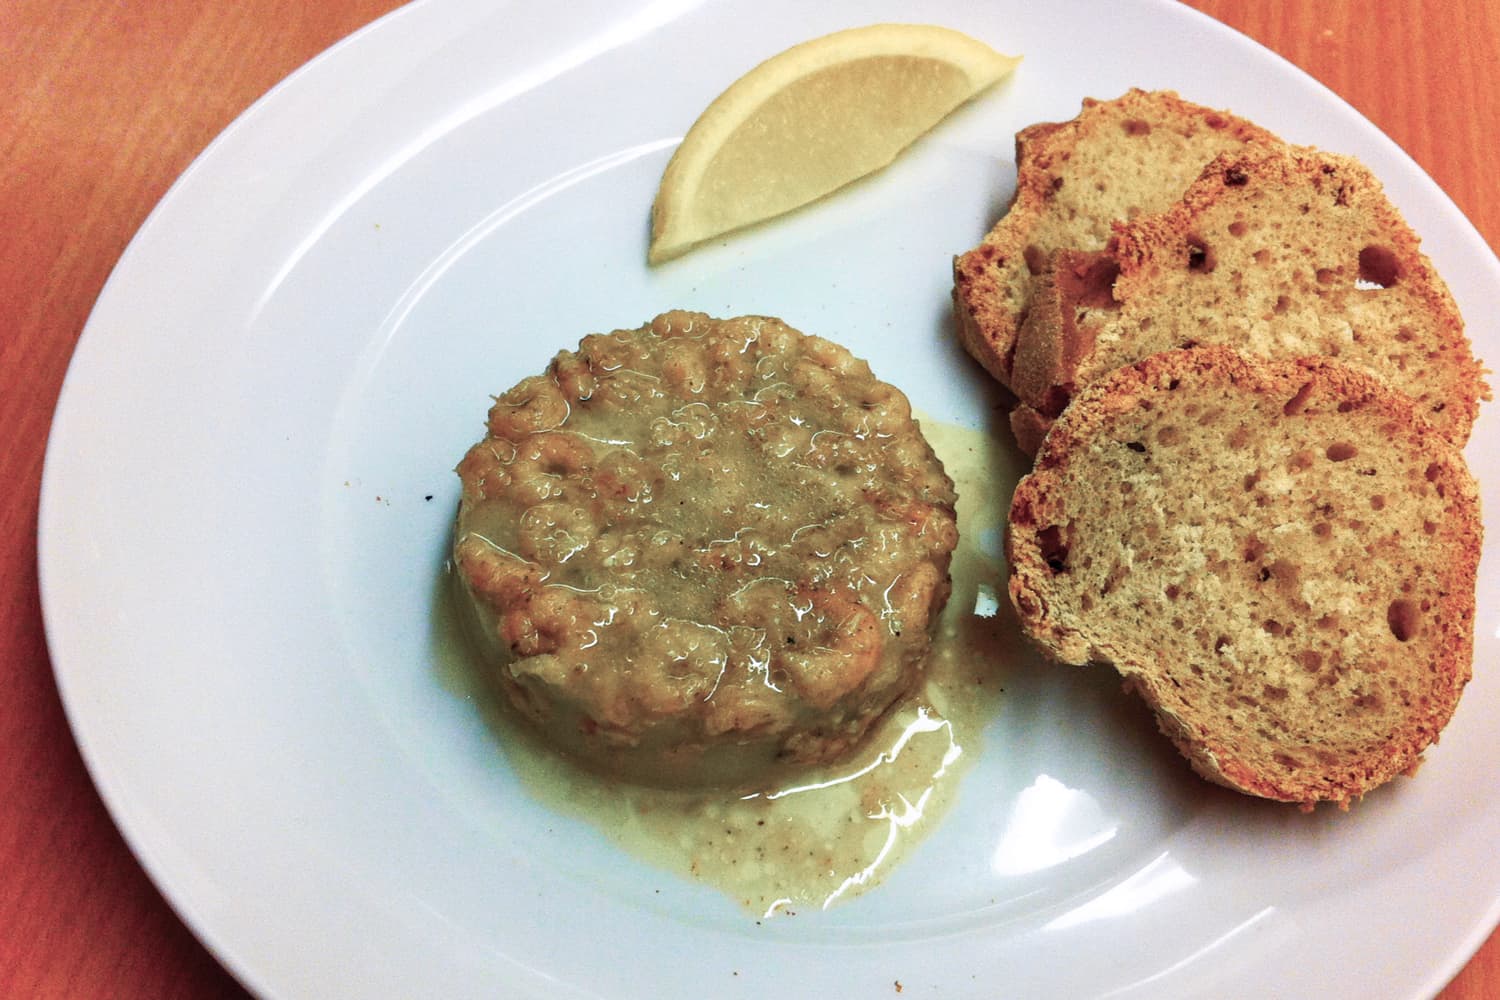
xmin=647 ymin=24 xmax=1020 ymax=264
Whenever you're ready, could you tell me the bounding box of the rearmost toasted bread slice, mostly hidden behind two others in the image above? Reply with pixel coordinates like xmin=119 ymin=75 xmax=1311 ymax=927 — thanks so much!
xmin=953 ymin=90 xmax=1278 ymax=385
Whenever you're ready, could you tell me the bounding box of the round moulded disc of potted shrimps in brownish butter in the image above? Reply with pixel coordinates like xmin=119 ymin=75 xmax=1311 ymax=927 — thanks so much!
xmin=453 ymin=312 xmax=959 ymax=786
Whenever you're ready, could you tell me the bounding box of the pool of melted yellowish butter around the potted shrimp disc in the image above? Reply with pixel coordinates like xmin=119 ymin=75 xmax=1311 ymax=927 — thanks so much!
xmin=450 ymin=418 xmax=1017 ymax=918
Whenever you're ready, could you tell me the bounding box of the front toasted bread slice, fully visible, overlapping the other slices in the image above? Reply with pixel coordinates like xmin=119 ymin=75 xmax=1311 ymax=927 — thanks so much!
xmin=1007 ymin=346 xmax=1482 ymax=808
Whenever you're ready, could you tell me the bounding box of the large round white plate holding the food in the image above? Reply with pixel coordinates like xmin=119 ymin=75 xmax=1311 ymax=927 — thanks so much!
xmin=41 ymin=0 xmax=1500 ymax=997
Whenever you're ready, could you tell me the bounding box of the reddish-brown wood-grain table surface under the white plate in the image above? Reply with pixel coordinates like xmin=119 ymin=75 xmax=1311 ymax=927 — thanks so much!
xmin=0 ymin=0 xmax=1500 ymax=1000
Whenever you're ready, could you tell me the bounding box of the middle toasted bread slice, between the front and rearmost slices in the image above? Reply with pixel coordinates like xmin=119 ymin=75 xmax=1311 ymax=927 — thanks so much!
xmin=1011 ymin=145 xmax=1490 ymax=447
